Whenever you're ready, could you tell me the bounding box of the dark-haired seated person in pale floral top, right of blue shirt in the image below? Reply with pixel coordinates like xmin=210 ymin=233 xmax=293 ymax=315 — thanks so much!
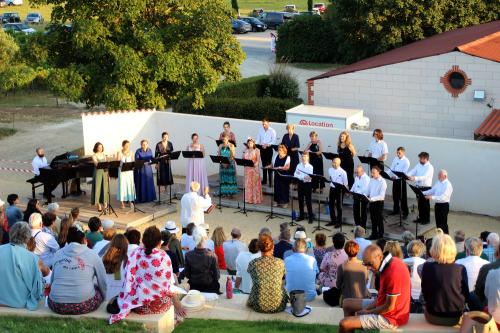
xmin=319 ymin=233 xmax=348 ymax=288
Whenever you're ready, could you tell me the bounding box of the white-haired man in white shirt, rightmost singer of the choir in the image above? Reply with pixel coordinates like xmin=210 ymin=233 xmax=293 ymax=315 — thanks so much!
xmin=423 ymin=169 xmax=453 ymax=234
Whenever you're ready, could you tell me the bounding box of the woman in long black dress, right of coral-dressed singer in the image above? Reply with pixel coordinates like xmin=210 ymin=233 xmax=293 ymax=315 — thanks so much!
xmin=273 ymin=144 xmax=290 ymax=208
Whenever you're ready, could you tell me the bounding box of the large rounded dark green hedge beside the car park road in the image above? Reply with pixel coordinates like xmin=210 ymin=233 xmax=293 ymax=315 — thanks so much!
xmin=276 ymin=15 xmax=338 ymax=63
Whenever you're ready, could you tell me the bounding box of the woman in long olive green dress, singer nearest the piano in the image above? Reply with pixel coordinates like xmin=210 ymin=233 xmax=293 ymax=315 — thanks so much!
xmin=91 ymin=142 xmax=109 ymax=212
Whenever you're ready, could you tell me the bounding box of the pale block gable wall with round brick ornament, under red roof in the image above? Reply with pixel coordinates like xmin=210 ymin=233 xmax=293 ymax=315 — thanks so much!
xmin=314 ymin=52 xmax=500 ymax=139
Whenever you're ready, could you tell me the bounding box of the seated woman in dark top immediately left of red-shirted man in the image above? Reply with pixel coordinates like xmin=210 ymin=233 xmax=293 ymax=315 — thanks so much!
xmin=337 ymin=240 xmax=370 ymax=299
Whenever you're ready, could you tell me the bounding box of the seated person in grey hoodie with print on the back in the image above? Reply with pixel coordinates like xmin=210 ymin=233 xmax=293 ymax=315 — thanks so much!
xmin=48 ymin=227 xmax=106 ymax=315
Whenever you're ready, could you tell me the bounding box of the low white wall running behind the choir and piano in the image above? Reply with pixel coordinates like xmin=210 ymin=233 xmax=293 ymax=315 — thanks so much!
xmin=82 ymin=111 xmax=500 ymax=216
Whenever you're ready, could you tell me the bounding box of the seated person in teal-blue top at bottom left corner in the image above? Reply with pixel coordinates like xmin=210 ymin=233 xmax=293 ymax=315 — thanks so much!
xmin=0 ymin=222 xmax=48 ymax=311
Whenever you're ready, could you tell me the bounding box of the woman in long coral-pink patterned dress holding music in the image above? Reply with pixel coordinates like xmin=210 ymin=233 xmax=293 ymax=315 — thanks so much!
xmin=243 ymin=138 xmax=262 ymax=204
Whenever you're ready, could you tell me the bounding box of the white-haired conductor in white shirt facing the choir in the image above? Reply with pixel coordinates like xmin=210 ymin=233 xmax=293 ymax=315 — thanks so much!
xmin=181 ymin=182 xmax=212 ymax=228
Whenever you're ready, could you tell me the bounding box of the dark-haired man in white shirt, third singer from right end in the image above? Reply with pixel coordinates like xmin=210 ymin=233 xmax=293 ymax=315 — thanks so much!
xmin=389 ymin=147 xmax=410 ymax=218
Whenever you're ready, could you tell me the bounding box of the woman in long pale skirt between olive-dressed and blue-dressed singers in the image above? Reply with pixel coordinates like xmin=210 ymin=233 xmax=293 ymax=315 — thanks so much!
xmin=116 ymin=140 xmax=135 ymax=208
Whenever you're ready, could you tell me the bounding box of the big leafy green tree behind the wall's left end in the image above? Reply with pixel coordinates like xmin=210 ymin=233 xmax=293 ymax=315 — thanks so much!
xmin=29 ymin=0 xmax=244 ymax=109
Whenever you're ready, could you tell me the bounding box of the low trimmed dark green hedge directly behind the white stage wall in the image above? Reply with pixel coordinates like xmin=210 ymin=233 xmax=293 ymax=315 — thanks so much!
xmin=174 ymin=96 xmax=302 ymax=123
